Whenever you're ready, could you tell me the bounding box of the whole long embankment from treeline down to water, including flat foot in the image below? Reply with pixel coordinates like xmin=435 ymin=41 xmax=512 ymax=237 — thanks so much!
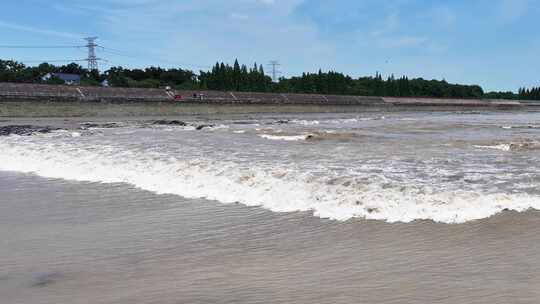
xmin=0 ymin=83 xmax=528 ymax=117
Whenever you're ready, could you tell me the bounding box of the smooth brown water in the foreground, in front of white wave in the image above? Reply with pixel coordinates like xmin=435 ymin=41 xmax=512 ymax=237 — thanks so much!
xmin=0 ymin=172 xmax=540 ymax=304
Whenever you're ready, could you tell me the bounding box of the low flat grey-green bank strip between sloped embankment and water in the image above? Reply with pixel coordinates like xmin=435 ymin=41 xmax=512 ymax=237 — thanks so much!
xmin=0 ymin=100 xmax=540 ymax=118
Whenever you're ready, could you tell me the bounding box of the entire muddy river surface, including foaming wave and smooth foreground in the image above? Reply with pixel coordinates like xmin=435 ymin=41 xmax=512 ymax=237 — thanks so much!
xmin=0 ymin=112 xmax=540 ymax=303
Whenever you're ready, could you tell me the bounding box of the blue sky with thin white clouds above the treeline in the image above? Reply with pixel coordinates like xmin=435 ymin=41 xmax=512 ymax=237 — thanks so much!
xmin=0 ymin=0 xmax=540 ymax=91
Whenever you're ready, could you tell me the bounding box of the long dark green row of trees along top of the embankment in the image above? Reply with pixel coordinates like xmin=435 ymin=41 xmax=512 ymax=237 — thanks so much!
xmin=0 ymin=60 xmax=540 ymax=100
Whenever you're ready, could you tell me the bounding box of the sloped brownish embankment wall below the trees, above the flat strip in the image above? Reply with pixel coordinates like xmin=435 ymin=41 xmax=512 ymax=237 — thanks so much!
xmin=0 ymin=83 xmax=530 ymax=108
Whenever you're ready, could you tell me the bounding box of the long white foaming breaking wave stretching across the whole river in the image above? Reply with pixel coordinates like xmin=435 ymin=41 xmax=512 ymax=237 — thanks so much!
xmin=0 ymin=138 xmax=540 ymax=223
